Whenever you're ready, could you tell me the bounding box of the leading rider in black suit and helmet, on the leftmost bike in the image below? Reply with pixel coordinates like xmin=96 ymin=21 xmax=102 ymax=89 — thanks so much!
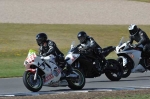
xmin=36 ymin=33 xmax=71 ymax=75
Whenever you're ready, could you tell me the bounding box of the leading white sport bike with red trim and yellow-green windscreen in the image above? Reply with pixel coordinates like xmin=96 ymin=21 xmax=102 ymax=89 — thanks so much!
xmin=23 ymin=49 xmax=85 ymax=92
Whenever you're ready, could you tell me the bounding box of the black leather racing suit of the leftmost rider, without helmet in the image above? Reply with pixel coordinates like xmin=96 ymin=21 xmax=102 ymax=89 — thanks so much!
xmin=39 ymin=40 xmax=64 ymax=65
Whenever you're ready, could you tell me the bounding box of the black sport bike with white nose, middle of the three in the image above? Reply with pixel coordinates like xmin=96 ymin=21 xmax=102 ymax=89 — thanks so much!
xmin=65 ymin=43 xmax=122 ymax=81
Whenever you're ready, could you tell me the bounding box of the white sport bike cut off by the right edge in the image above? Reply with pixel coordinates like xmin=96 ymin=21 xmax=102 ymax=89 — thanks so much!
xmin=115 ymin=37 xmax=150 ymax=78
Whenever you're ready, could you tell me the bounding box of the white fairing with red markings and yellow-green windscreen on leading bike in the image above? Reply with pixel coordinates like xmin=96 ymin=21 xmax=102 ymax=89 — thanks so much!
xmin=24 ymin=50 xmax=61 ymax=87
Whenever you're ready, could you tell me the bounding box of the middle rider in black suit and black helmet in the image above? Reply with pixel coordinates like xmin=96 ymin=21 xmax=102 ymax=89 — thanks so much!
xmin=77 ymin=31 xmax=107 ymax=71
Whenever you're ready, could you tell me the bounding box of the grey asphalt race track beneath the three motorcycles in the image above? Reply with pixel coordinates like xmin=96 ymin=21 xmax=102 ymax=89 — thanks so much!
xmin=0 ymin=72 xmax=150 ymax=96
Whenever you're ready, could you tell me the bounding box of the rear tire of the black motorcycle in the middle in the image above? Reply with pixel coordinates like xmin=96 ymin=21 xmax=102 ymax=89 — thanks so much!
xmin=105 ymin=59 xmax=123 ymax=81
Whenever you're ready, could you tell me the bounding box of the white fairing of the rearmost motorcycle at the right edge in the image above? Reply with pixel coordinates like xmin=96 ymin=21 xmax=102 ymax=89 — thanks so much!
xmin=115 ymin=38 xmax=146 ymax=73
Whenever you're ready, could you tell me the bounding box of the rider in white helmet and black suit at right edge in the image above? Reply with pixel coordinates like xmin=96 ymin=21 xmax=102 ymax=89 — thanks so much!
xmin=128 ymin=24 xmax=150 ymax=56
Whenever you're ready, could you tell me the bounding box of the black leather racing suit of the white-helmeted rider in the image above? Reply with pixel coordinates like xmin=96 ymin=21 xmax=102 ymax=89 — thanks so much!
xmin=129 ymin=28 xmax=150 ymax=52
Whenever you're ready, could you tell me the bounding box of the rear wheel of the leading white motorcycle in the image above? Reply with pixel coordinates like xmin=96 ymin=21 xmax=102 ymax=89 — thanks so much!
xmin=67 ymin=69 xmax=85 ymax=90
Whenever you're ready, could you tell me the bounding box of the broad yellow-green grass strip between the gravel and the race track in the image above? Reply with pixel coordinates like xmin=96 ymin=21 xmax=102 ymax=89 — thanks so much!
xmin=0 ymin=23 xmax=150 ymax=77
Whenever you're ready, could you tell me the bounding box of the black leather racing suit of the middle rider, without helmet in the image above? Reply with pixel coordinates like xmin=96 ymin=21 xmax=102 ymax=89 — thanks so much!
xmin=79 ymin=36 xmax=106 ymax=67
